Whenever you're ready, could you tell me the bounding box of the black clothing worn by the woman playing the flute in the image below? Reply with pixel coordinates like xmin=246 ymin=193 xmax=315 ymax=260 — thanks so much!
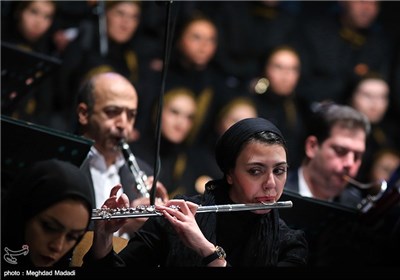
xmin=84 ymin=180 xmax=307 ymax=267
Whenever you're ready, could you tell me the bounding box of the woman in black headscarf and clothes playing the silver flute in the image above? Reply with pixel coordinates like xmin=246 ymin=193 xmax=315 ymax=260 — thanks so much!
xmin=84 ymin=118 xmax=308 ymax=268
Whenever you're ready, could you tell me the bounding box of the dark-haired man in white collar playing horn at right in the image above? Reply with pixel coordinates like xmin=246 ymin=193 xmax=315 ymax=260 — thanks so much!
xmin=286 ymin=102 xmax=370 ymax=207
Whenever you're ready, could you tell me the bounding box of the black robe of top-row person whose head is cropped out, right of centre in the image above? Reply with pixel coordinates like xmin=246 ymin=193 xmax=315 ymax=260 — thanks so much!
xmin=213 ymin=1 xmax=298 ymax=88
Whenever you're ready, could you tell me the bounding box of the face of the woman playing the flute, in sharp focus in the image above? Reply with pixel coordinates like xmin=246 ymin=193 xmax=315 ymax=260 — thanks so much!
xmin=227 ymin=142 xmax=288 ymax=214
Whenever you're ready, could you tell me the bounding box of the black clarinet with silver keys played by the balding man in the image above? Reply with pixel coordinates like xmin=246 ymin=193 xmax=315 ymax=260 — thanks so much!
xmin=119 ymin=139 xmax=150 ymax=198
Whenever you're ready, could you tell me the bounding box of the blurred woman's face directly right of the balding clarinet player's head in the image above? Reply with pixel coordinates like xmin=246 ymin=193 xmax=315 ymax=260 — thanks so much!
xmin=162 ymin=94 xmax=196 ymax=143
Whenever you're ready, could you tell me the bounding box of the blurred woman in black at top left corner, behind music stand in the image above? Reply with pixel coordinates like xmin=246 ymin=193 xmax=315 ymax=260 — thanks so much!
xmin=1 ymin=0 xmax=60 ymax=128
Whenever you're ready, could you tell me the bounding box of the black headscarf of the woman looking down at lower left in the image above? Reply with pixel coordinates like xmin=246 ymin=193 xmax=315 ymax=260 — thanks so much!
xmin=2 ymin=159 xmax=93 ymax=265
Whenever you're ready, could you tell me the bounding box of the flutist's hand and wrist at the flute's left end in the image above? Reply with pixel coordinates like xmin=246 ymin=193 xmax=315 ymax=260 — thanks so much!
xmin=92 ymin=184 xmax=129 ymax=259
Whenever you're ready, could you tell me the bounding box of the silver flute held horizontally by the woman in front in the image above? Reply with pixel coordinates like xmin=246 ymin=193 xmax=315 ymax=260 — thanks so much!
xmin=92 ymin=200 xmax=293 ymax=220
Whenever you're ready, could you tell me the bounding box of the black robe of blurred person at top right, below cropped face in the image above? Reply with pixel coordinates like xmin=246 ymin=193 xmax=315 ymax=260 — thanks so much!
xmin=293 ymin=15 xmax=392 ymax=108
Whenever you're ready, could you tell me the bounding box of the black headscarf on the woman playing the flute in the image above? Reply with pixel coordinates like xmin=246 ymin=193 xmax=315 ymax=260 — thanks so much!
xmin=215 ymin=118 xmax=285 ymax=174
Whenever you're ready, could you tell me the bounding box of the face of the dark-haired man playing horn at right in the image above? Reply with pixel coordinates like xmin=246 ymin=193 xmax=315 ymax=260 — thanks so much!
xmin=306 ymin=125 xmax=366 ymax=200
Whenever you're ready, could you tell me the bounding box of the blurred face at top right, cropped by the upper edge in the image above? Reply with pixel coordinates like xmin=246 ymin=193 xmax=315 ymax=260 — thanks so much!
xmin=342 ymin=0 xmax=379 ymax=29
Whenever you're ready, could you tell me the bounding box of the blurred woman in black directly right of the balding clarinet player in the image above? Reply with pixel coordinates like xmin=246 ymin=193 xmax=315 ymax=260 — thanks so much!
xmin=131 ymin=88 xmax=197 ymax=197
